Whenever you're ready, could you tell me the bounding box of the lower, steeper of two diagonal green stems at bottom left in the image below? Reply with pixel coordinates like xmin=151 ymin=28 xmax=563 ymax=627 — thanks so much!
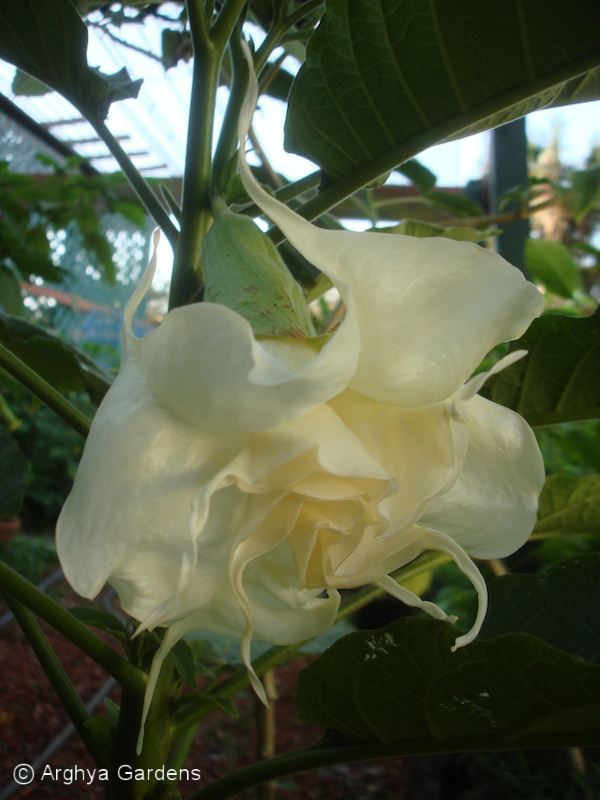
xmin=2 ymin=593 xmax=108 ymax=767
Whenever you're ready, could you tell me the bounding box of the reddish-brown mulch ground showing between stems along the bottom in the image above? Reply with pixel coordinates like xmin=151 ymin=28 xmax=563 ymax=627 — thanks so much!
xmin=0 ymin=589 xmax=410 ymax=800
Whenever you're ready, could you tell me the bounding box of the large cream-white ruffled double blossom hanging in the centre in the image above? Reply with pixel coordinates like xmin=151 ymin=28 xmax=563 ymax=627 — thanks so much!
xmin=57 ymin=50 xmax=544 ymax=744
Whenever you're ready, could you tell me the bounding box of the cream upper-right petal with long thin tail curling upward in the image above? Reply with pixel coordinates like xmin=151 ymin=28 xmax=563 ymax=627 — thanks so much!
xmin=239 ymin=49 xmax=543 ymax=407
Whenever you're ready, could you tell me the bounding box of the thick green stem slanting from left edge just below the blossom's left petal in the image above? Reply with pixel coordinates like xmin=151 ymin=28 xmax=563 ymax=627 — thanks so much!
xmin=0 ymin=561 xmax=147 ymax=691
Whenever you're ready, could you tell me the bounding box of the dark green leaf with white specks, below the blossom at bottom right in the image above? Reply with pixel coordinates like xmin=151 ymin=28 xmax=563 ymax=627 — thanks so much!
xmin=297 ymin=619 xmax=600 ymax=752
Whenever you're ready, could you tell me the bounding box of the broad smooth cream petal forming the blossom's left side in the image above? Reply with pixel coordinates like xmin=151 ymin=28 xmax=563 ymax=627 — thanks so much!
xmin=57 ymin=360 xmax=248 ymax=604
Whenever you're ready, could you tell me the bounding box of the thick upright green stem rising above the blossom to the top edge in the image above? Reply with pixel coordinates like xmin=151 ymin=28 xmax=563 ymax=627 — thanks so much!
xmin=169 ymin=0 xmax=223 ymax=309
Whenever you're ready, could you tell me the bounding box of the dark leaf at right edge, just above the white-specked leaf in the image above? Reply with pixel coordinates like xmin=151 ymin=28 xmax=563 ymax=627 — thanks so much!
xmin=479 ymin=552 xmax=600 ymax=663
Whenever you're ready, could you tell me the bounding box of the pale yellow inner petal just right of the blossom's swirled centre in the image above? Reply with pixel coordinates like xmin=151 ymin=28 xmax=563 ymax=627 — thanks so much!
xmin=329 ymin=390 xmax=467 ymax=534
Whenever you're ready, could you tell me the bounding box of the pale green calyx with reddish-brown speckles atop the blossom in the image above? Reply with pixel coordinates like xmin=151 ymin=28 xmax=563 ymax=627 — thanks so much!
xmin=202 ymin=213 xmax=314 ymax=339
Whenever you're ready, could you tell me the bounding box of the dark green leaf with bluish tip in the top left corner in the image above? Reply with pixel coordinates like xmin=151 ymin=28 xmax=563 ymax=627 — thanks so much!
xmin=0 ymin=0 xmax=141 ymax=120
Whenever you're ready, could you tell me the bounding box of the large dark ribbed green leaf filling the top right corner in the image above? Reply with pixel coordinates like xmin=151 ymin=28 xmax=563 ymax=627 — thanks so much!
xmin=285 ymin=0 xmax=600 ymax=188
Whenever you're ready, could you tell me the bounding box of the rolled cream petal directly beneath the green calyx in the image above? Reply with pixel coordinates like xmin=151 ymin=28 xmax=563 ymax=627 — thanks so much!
xmin=130 ymin=296 xmax=358 ymax=432
